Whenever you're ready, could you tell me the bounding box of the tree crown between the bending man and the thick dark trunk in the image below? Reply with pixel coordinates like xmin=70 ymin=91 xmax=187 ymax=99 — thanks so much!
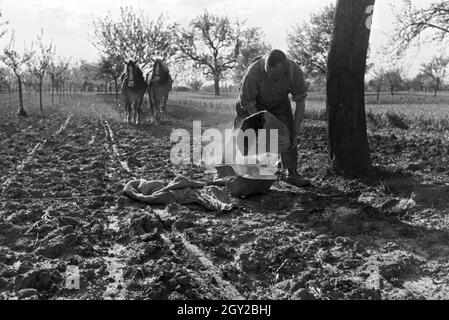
xmin=287 ymin=4 xmax=335 ymax=80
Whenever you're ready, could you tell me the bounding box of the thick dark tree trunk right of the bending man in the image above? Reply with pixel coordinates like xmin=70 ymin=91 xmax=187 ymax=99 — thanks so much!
xmin=327 ymin=0 xmax=375 ymax=176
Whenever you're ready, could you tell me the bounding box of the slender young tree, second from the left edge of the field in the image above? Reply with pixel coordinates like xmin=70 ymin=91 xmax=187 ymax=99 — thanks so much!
xmin=28 ymin=30 xmax=55 ymax=111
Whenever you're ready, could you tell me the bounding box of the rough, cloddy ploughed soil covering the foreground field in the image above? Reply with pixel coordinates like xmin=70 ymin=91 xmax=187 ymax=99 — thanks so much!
xmin=0 ymin=95 xmax=449 ymax=299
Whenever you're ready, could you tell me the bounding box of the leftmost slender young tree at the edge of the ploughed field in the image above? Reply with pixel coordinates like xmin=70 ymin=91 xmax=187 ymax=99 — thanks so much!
xmin=0 ymin=32 xmax=33 ymax=117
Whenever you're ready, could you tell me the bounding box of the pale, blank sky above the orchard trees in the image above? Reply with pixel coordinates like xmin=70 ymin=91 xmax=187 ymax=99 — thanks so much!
xmin=0 ymin=0 xmax=436 ymax=75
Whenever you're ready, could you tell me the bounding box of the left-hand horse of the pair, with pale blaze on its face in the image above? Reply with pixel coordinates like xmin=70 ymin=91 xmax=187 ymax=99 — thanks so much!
xmin=121 ymin=60 xmax=148 ymax=125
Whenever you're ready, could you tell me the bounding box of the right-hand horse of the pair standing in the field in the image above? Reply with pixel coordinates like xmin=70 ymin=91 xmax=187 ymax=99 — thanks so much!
xmin=147 ymin=59 xmax=173 ymax=122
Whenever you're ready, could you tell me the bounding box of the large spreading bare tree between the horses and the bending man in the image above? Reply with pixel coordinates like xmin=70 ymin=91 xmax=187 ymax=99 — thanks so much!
xmin=177 ymin=11 xmax=244 ymax=96
